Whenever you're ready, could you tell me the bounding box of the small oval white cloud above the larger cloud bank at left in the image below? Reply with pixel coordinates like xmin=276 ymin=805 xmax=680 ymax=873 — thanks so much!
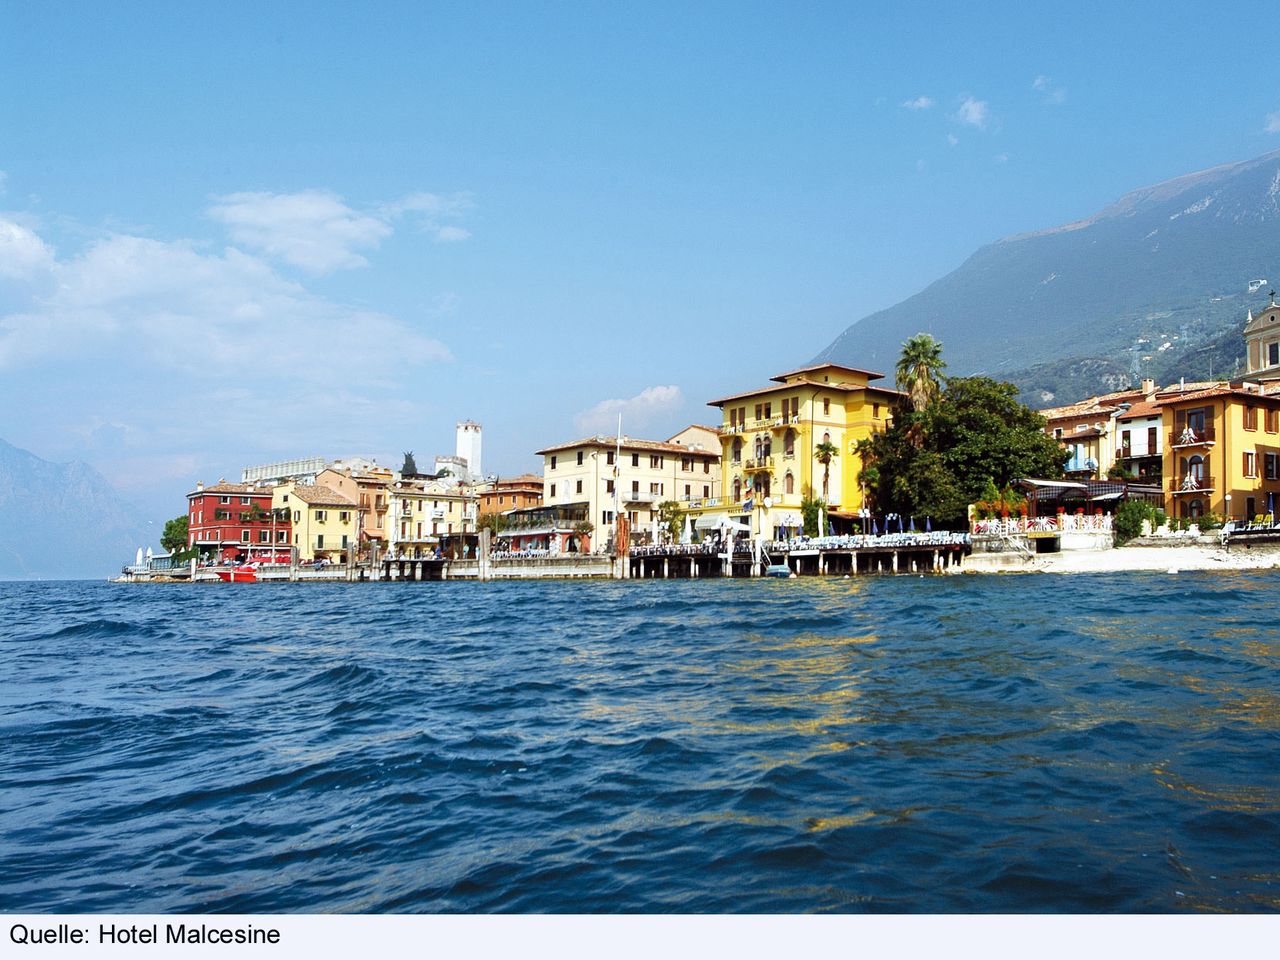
xmin=209 ymin=191 xmax=392 ymax=274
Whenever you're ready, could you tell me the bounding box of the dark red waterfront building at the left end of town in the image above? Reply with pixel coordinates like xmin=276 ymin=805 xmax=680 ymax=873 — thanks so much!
xmin=187 ymin=480 xmax=291 ymax=563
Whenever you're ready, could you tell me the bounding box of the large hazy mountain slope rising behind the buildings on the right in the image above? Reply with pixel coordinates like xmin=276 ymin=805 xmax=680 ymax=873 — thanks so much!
xmin=817 ymin=151 xmax=1280 ymax=401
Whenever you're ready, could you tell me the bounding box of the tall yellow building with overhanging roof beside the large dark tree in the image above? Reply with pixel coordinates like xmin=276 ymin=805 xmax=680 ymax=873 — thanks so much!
xmin=699 ymin=364 xmax=901 ymax=539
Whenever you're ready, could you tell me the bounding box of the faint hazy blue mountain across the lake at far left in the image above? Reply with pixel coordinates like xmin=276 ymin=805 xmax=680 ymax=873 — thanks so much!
xmin=0 ymin=440 xmax=151 ymax=580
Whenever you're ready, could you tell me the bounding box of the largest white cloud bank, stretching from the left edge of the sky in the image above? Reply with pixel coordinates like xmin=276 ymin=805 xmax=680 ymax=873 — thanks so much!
xmin=0 ymin=220 xmax=449 ymax=378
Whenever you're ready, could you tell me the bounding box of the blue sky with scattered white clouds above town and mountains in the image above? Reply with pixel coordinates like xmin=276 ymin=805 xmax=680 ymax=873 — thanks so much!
xmin=0 ymin=3 xmax=1280 ymax=527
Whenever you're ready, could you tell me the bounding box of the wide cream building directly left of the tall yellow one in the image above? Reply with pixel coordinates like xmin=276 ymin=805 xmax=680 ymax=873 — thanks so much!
xmin=538 ymin=425 xmax=721 ymax=549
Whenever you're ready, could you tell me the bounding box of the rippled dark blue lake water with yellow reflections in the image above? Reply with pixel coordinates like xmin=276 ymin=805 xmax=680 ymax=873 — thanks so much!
xmin=0 ymin=573 xmax=1280 ymax=913
